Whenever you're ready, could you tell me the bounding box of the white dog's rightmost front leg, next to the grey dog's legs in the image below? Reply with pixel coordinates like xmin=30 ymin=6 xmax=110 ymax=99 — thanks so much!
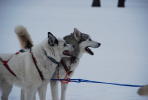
xmin=38 ymin=83 xmax=48 ymax=100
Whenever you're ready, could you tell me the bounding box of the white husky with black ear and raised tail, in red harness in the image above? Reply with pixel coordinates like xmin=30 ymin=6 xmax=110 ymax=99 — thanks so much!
xmin=0 ymin=27 xmax=73 ymax=100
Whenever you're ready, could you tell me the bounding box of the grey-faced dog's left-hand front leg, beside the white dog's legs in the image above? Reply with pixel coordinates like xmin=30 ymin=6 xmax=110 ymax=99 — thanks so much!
xmin=50 ymin=80 xmax=59 ymax=100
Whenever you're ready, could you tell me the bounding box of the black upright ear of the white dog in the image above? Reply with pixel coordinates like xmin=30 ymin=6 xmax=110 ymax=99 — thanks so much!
xmin=48 ymin=32 xmax=59 ymax=46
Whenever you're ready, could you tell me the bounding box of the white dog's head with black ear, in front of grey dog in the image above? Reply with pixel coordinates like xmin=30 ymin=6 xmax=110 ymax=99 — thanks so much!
xmin=48 ymin=32 xmax=73 ymax=57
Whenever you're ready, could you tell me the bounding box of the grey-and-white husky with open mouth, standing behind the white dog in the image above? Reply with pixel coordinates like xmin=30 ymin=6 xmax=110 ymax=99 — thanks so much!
xmin=50 ymin=28 xmax=101 ymax=100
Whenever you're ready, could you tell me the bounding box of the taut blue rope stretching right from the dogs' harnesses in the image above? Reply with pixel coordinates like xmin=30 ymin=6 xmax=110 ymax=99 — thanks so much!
xmin=51 ymin=79 xmax=144 ymax=87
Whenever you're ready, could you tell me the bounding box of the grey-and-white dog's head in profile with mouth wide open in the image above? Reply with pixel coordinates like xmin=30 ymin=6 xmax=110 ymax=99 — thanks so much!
xmin=64 ymin=28 xmax=101 ymax=55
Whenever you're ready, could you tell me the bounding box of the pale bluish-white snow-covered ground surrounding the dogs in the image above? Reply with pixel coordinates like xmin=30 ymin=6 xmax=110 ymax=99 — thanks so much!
xmin=0 ymin=0 xmax=148 ymax=100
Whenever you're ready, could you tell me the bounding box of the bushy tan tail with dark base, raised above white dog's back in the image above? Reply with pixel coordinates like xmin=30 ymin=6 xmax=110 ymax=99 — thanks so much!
xmin=15 ymin=26 xmax=33 ymax=49
